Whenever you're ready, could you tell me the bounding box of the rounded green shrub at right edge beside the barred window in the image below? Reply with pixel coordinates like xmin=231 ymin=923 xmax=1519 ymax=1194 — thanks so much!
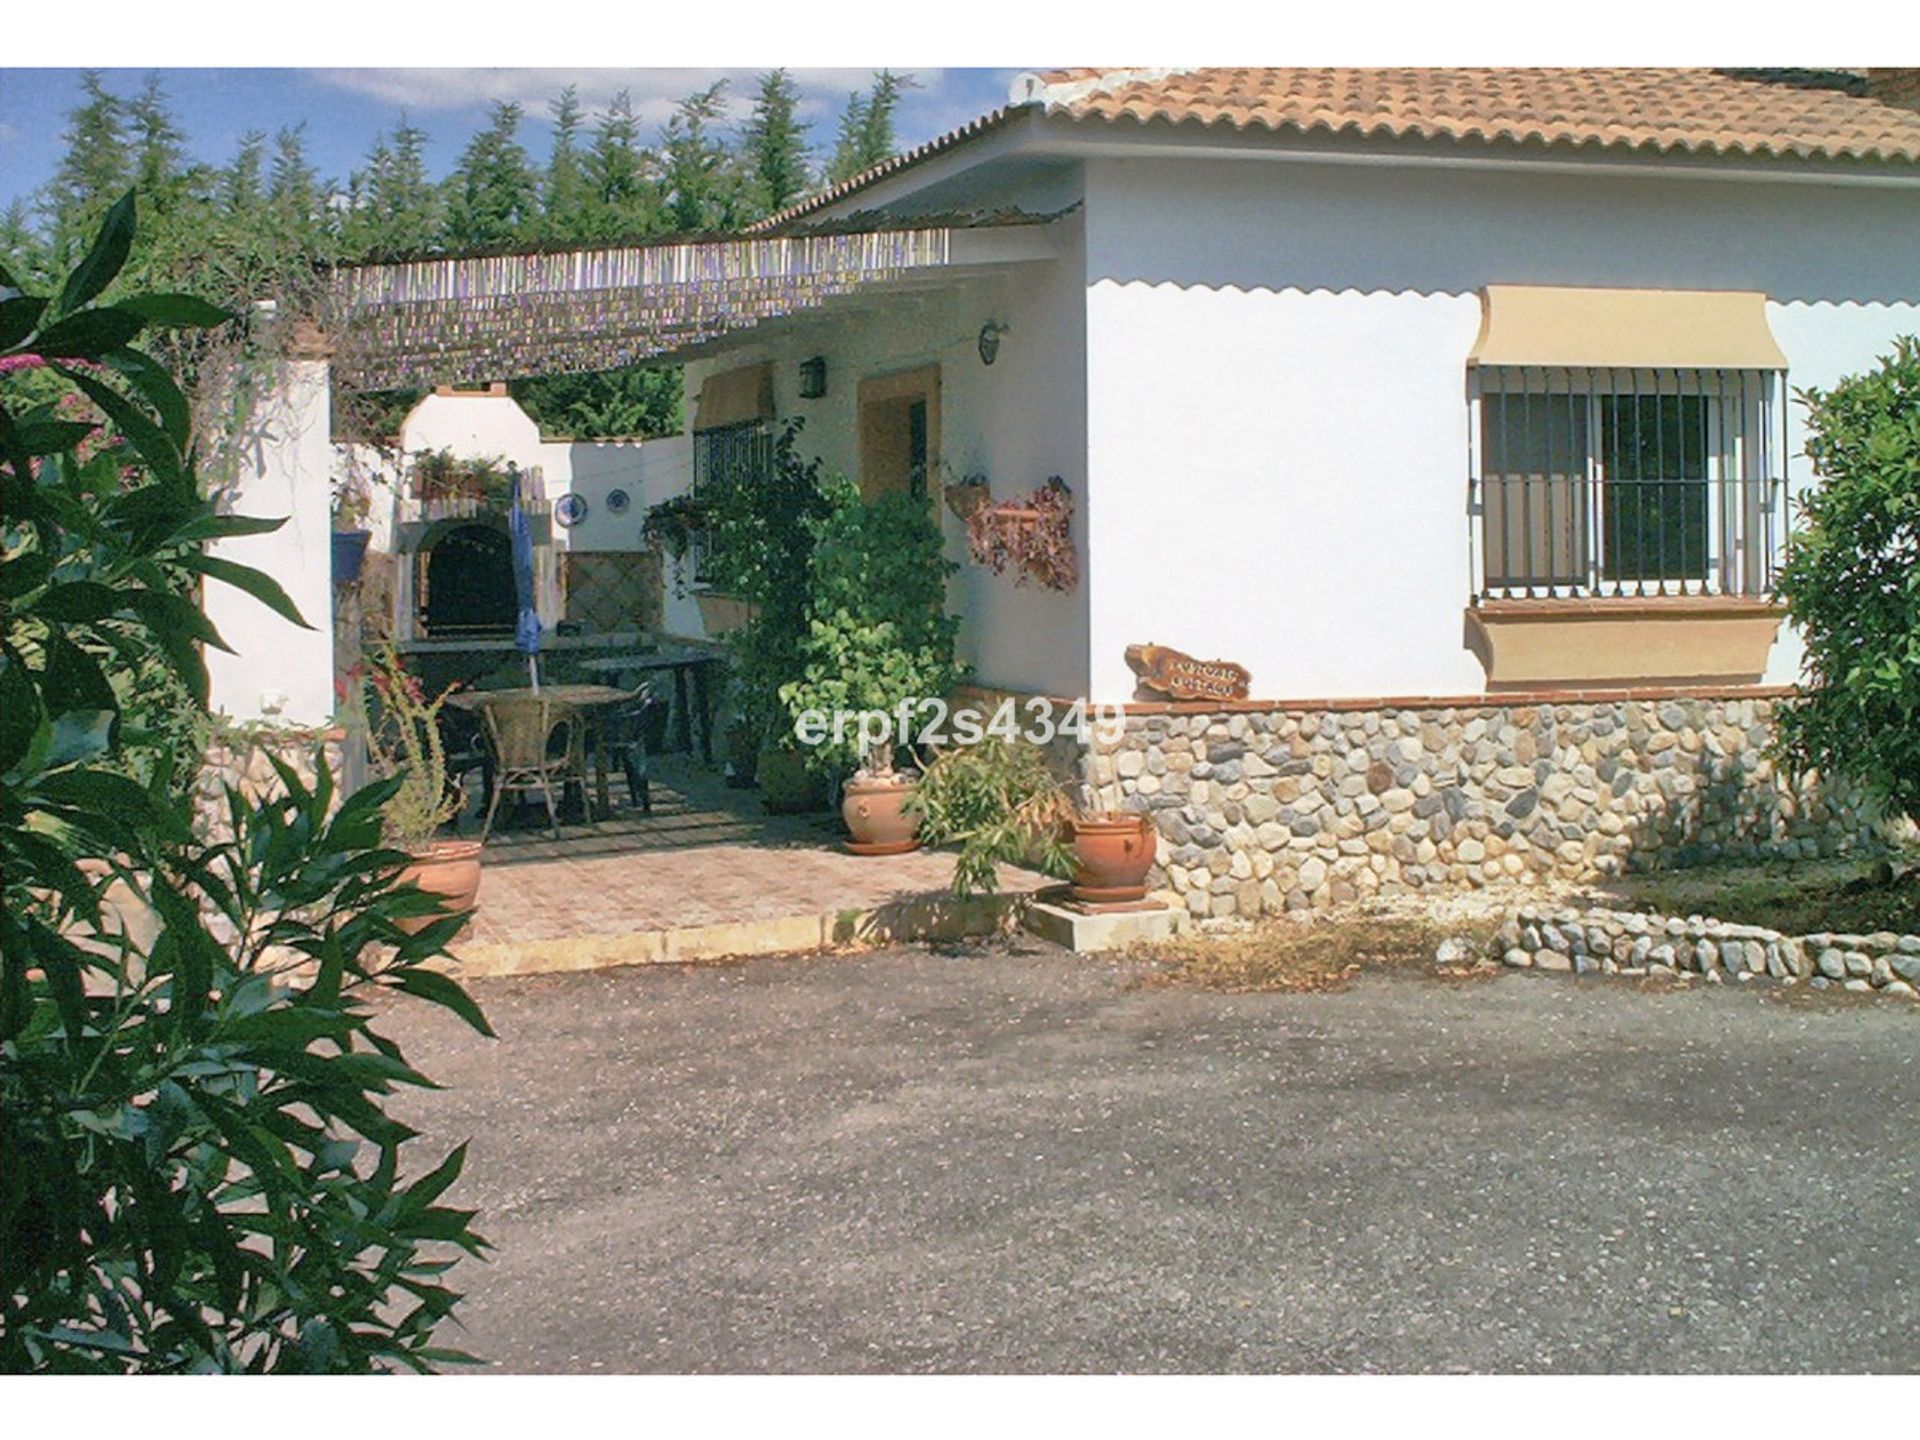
xmin=1778 ymin=336 xmax=1920 ymax=820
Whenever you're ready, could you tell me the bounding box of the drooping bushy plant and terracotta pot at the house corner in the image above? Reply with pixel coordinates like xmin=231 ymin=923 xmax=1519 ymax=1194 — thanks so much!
xmin=908 ymin=737 xmax=1158 ymax=904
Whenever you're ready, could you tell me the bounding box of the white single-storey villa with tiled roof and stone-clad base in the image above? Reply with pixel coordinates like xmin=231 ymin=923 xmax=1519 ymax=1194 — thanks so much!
xmin=209 ymin=69 xmax=1920 ymax=914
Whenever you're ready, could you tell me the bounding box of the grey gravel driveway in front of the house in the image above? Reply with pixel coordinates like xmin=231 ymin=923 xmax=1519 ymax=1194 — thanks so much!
xmin=388 ymin=945 xmax=1920 ymax=1373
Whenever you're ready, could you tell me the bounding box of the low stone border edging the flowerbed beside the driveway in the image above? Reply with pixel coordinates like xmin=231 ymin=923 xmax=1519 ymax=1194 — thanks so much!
xmin=1489 ymin=908 xmax=1920 ymax=1000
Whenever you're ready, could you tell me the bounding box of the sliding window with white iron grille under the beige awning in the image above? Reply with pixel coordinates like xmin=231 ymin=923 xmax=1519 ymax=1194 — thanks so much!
xmin=1471 ymin=365 xmax=1786 ymax=599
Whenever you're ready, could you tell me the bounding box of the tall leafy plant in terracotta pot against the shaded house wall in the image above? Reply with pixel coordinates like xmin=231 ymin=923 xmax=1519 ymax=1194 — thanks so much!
xmin=780 ymin=480 xmax=960 ymax=854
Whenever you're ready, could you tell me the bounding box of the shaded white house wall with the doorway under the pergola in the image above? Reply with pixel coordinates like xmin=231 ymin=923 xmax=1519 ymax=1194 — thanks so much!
xmin=670 ymin=221 xmax=1089 ymax=695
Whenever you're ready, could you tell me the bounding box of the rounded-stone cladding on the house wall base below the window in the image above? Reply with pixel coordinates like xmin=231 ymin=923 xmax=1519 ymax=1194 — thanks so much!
xmin=1087 ymin=699 xmax=1882 ymax=916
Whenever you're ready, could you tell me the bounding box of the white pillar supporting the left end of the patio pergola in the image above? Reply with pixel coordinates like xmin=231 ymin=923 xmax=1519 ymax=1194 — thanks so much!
xmin=205 ymin=357 xmax=334 ymax=726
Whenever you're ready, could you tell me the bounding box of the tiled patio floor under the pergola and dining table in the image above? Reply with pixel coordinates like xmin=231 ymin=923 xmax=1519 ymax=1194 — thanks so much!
xmin=453 ymin=760 xmax=1044 ymax=973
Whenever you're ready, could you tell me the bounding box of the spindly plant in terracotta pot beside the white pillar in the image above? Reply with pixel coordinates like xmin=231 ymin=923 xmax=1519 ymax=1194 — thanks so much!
xmin=365 ymin=645 xmax=480 ymax=931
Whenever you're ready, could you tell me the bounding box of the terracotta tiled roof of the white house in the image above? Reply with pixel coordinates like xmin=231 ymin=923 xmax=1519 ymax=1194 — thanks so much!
xmin=1041 ymin=67 xmax=1920 ymax=163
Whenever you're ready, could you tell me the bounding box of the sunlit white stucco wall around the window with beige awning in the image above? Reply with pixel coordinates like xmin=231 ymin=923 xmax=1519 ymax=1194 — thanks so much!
xmin=1087 ymin=157 xmax=1920 ymax=701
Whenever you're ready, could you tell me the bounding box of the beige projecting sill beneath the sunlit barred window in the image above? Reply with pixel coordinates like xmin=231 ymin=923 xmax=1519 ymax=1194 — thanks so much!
xmin=1467 ymin=595 xmax=1786 ymax=689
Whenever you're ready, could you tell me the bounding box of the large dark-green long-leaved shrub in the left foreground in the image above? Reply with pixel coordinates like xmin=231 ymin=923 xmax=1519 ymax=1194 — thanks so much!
xmin=0 ymin=194 xmax=486 ymax=1373
